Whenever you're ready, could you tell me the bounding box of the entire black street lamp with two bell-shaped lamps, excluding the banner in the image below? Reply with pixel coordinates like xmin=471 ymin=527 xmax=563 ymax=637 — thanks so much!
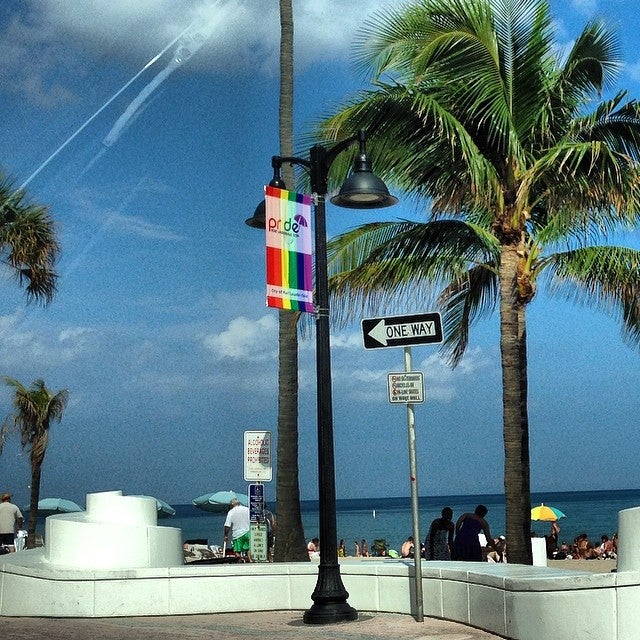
xmin=246 ymin=131 xmax=398 ymax=624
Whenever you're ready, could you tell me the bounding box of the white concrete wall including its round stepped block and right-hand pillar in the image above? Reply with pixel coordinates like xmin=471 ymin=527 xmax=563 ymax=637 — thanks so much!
xmin=0 ymin=492 xmax=640 ymax=640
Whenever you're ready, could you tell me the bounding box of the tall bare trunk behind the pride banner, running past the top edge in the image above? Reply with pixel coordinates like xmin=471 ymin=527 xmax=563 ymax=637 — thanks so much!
xmin=274 ymin=0 xmax=309 ymax=562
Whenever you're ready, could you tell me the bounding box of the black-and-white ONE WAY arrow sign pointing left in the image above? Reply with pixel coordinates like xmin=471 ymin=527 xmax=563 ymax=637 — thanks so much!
xmin=362 ymin=313 xmax=442 ymax=349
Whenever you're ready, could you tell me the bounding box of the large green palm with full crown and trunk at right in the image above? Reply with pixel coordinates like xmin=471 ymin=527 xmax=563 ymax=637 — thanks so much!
xmin=321 ymin=0 xmax=640 ymax=564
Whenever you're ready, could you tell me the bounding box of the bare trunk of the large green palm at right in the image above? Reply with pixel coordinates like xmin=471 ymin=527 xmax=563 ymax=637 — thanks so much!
xmin=500 ymin=244 xmax=533 ymax=564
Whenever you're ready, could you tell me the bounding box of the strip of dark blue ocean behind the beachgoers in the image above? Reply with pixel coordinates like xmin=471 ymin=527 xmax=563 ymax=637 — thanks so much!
xmin=158 ymin=489 xmax=640 ymax=555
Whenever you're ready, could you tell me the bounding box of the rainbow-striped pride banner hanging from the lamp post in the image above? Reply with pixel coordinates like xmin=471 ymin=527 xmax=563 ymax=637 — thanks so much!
xmin=265 ymin=186 xmax=315 ymax=313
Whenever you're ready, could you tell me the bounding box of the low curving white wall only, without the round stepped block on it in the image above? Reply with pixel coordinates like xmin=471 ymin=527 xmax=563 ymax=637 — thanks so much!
xmin=0 ymin=549 xmax=640 ymax=640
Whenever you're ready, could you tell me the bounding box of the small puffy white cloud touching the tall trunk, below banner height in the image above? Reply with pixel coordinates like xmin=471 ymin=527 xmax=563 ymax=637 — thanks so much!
xmin=202 ymin=315 xmax=278 ymax=362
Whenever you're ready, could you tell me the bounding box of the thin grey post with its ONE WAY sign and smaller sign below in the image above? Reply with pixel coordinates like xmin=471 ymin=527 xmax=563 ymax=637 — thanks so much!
xmin=361 ymin=313 xmax=443 ymax=622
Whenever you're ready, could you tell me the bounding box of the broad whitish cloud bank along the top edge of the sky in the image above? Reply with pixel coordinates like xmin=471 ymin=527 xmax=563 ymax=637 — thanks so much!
xmin=0 ymin=0 xmax=387 ymax=107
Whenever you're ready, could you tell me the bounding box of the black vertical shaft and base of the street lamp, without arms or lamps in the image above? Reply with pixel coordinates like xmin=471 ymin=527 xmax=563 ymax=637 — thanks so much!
xmin=303 ymin=172 xmax=358 ymax=624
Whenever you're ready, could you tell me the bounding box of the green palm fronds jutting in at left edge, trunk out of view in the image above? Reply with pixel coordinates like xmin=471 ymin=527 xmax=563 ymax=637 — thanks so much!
xmin=0 ymin=180 xmax=60 ymax=304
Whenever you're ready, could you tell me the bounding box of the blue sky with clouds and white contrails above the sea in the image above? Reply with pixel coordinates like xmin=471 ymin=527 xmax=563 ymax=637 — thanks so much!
xmin=0 ymin=0 xmax=640 ymax=506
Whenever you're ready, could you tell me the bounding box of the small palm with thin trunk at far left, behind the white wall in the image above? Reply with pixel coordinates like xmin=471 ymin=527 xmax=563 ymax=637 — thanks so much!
xmin=2 ymin=376 xmax=69 ymax=549
